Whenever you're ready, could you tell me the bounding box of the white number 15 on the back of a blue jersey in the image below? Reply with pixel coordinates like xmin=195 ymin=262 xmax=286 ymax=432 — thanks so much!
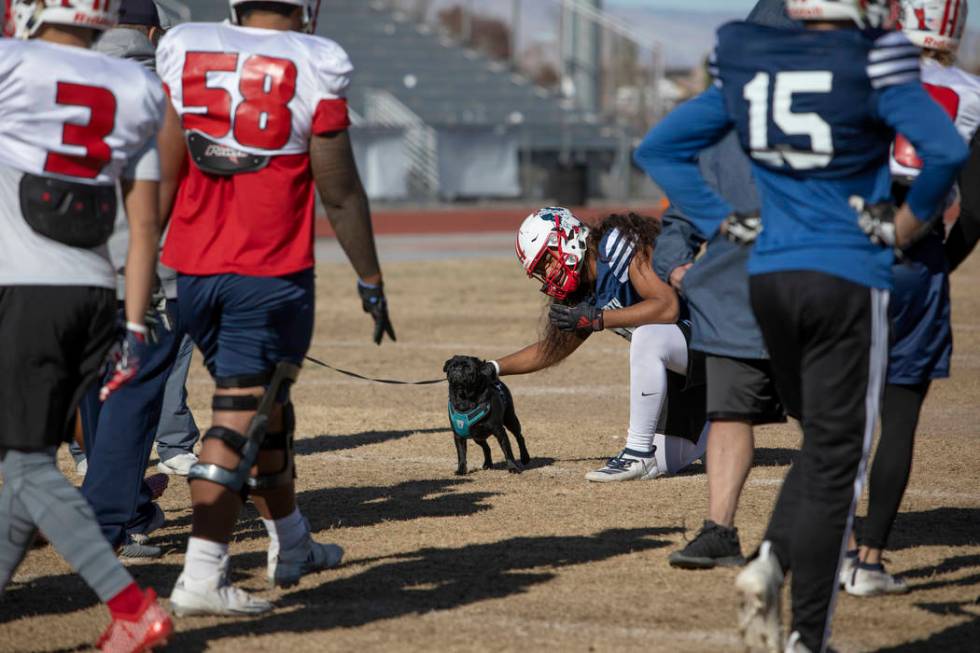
xmin=742 ymin=71 xmax=834 ymax=170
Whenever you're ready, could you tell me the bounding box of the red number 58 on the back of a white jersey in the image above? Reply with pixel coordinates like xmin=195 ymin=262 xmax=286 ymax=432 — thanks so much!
xmin=182 ymin=52 xmax=296 ymax=150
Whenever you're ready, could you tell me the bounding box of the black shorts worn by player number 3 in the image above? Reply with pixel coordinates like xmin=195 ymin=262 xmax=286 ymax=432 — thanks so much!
xmin=0 ymin=286 xmax=116 ymax=451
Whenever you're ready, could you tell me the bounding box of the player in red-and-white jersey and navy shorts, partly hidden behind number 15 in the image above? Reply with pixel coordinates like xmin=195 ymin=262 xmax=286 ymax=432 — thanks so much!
xmin=841 ymin=0 xmax=980 ymax=596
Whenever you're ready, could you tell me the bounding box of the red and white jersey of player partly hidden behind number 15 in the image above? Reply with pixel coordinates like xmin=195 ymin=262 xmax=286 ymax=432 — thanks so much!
xmin=891 ymin=59 xmax=980 ymax=177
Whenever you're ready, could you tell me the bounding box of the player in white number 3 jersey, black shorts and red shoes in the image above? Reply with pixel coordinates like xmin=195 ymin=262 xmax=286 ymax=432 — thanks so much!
xmin=0 ymin=0 xmax=172 ymax=651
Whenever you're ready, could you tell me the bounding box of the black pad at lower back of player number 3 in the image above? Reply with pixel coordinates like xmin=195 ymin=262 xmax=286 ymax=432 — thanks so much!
xmin=20 ymin=173 xmax=116 ymax=249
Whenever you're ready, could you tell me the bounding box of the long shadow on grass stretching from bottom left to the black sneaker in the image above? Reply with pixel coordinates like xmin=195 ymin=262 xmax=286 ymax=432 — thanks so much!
xmin=172 ymin=528 xmax=679 ymax=651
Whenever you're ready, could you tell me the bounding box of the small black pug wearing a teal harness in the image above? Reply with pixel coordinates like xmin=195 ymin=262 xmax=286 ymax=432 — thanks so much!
xmin=442 ymin=356 xmax=531 ymax=476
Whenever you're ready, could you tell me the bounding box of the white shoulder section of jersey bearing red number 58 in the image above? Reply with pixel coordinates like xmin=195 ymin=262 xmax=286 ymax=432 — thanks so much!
xmin=157 ymin=23 xmax=352 ymax=156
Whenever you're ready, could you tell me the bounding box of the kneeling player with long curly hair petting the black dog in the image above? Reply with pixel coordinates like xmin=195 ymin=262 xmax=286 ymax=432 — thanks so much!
xmin=472 ymin=207 xmax=706 ymax=483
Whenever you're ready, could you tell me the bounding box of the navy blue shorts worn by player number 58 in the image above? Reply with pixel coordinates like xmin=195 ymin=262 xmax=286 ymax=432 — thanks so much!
xmin=177 ymin=270 xmax=314 ymax=385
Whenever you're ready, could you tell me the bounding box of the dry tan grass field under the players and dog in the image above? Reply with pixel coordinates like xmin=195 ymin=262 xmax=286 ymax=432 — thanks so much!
xmin=0 ymin=256 xmax=980 ymax=653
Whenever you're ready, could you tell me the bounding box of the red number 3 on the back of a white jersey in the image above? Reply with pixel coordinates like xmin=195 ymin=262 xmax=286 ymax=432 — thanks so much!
xmin=44 ymin=82 xmax=116 ymax=179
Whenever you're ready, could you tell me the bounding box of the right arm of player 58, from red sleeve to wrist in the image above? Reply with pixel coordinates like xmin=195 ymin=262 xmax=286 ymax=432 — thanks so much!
xmin=310 ymin=131 xmax=381 ymax=285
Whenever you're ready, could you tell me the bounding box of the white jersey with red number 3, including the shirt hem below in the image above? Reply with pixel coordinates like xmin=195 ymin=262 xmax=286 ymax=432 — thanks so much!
xmin=0 ymin=39 xmax=166 ymax=288
